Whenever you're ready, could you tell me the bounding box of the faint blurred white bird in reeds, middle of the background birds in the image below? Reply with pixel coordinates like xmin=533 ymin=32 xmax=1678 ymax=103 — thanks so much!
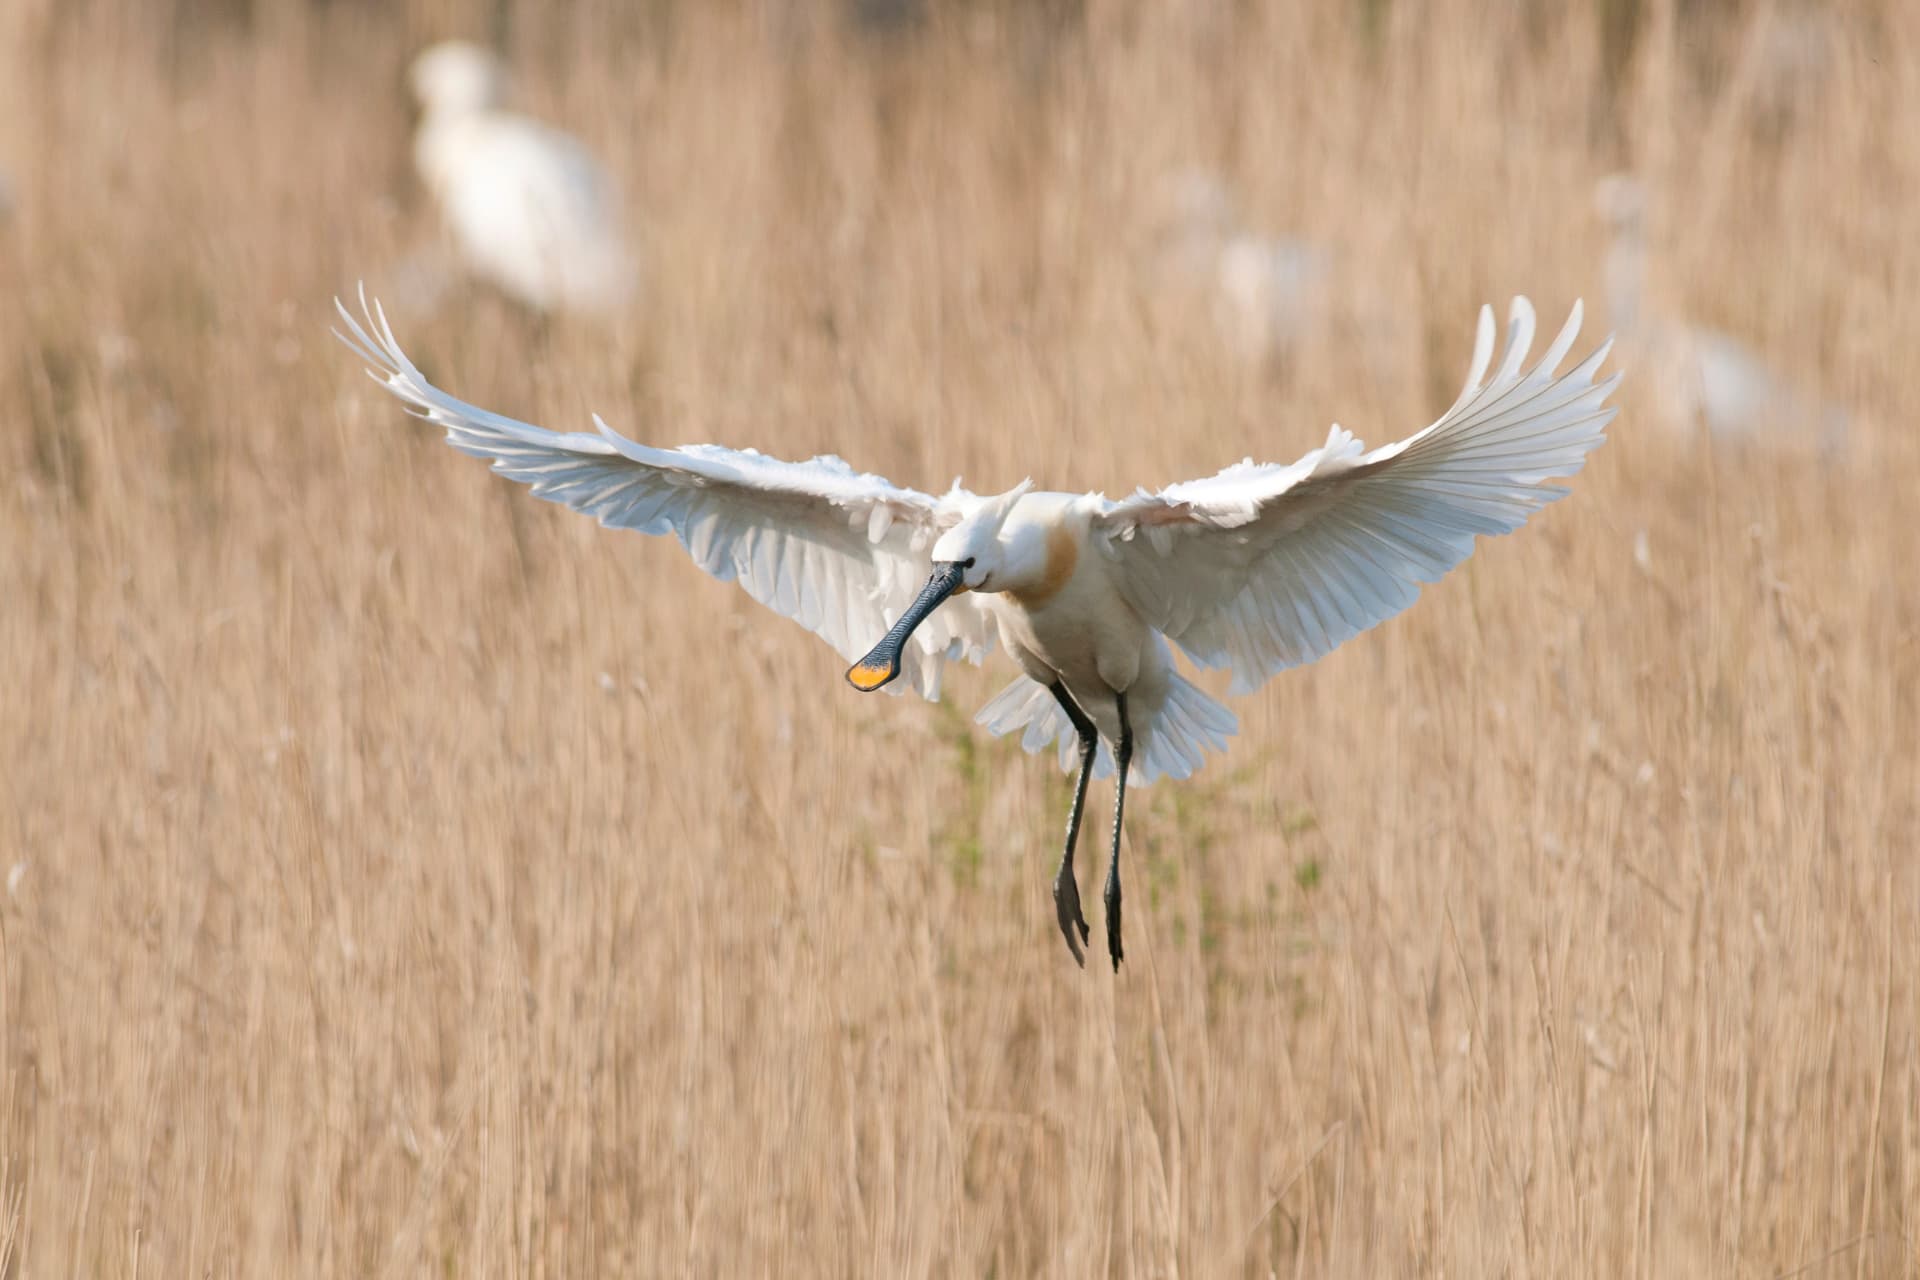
xmin=1154 ymin=171 xmax=1332 ymax=363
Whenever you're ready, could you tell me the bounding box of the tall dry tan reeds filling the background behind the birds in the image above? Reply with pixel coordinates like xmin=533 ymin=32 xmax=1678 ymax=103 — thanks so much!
xmin=0 ymin=0 xmax=1920 ymax=1276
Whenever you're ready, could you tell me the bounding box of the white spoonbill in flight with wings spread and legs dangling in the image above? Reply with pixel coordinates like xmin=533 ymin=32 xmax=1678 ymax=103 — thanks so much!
xmin=336 ymin=294 xmax=1619 ymax=971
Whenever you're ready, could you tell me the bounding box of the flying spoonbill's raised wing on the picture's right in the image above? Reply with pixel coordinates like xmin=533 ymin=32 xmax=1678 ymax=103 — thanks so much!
xmin=1094 ymin=297 xmax=1619 ymax=693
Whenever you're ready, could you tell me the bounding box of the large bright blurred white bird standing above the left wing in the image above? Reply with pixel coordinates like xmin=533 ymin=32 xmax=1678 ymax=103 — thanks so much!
xmin=411 ymin=40 xmax=636 ymax=311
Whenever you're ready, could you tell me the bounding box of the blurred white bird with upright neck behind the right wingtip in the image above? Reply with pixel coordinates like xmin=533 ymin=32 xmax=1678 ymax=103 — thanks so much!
xmin=1594 ymin=173 xmax=1847 ymax=453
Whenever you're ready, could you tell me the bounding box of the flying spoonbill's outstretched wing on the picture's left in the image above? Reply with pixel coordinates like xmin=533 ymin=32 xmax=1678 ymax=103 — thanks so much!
xmin=334 ymin=292 xmax=993 ymax=699
